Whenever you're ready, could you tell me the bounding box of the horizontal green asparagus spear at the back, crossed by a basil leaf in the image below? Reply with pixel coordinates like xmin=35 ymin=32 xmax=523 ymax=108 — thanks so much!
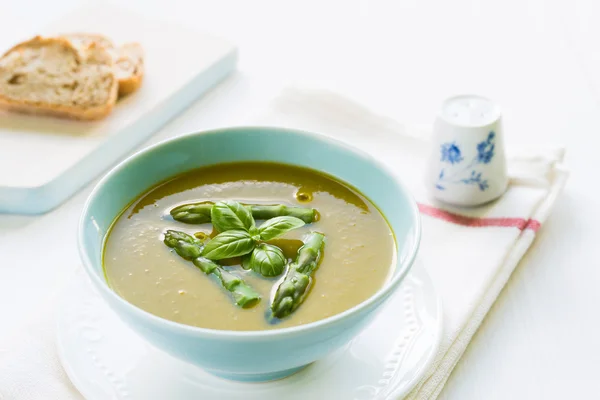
xmin=171 ymin=202 xmax=317 ymax=224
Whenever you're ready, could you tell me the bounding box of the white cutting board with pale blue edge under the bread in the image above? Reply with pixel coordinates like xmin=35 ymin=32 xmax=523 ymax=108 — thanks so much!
xmin=0 ymin=5 xmax=237 ymax=214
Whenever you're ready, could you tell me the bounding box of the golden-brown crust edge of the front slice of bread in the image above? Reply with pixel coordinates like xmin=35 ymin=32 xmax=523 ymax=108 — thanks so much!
xmin=0 ymin=36 xmax=118 ymax=120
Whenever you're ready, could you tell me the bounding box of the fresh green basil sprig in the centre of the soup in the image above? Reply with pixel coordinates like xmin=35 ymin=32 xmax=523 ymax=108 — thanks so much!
xmin=202 ymin=200 xmax=305 ymax=277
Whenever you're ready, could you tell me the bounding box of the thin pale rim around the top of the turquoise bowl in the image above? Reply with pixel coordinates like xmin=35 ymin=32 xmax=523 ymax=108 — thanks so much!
xmin=77 ymin=125 xmax=421 ymax=339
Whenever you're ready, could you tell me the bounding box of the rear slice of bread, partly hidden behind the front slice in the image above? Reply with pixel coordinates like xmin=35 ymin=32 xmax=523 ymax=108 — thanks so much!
xmin=61 ymin=33 xmax=144 ymax=96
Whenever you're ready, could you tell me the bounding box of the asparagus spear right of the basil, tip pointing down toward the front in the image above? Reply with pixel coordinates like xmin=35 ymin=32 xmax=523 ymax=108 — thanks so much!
xmin=271 ymin=232 xmax=325 ymax=318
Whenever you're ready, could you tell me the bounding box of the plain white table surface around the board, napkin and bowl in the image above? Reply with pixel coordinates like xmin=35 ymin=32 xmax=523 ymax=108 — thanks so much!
xmin=0 ymin=0 xmax=600 ymax=400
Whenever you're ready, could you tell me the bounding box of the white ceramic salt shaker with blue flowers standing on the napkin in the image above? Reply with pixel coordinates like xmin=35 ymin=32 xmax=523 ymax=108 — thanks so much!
xmin=427 ymin=95 xmax=508 ymax=206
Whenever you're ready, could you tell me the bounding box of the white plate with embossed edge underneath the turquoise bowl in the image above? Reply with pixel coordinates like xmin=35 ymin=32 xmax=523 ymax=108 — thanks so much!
xmin=57 ymin=264 xmax=442 ymax=400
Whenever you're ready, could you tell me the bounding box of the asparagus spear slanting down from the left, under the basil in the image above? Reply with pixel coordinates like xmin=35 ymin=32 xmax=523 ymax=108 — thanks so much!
xmin=164 ymin=230 xmax=260 ymax=308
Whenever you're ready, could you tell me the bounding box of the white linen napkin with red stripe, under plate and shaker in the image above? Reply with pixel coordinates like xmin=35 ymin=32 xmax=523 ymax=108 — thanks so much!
xmin=0 ymin=89 xmax=567 ymax=400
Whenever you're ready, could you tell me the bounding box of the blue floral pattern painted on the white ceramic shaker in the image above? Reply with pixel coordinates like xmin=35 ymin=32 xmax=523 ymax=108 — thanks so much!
xmin=435 ymin=132 xmax=496 ymax=192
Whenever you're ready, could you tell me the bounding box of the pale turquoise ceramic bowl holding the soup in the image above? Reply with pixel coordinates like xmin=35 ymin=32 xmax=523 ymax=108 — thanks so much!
xmin=79 ymin=127 xmax=421 ymax=381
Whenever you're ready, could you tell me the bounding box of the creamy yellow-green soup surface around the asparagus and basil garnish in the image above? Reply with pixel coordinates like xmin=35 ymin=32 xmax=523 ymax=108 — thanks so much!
xmin=103 ymin=162 xmax=396 ymax=330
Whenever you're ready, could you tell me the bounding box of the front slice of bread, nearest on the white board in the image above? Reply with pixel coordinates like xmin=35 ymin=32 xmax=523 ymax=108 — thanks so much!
xmin=0 ymin=36 xmax=118 ymax=120
